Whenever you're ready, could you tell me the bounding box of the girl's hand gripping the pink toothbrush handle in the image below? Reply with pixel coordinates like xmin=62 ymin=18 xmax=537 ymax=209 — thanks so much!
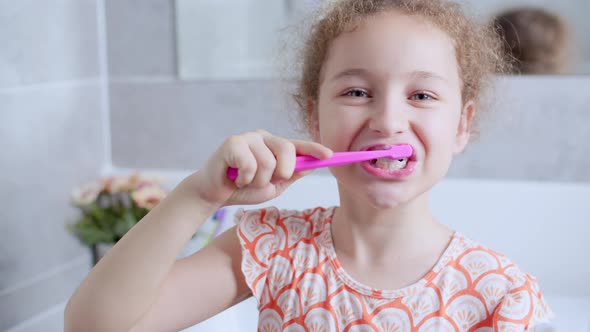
xmin=189 ymin=130 xmax=332 ymax=206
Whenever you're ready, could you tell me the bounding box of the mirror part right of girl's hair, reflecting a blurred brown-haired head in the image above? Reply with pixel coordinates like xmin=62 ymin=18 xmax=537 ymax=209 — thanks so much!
xmin=459 ymin=0 xmax=590 ymax=75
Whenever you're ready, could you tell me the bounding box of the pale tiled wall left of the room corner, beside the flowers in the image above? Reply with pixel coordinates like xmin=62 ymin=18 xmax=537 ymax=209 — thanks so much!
xmin=0 ymin=0 xmax=110 ymax=331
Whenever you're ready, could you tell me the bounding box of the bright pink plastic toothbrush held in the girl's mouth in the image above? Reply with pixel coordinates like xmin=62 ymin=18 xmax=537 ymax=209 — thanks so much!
xmin=227 ymin=144 xmax=414 ymax=180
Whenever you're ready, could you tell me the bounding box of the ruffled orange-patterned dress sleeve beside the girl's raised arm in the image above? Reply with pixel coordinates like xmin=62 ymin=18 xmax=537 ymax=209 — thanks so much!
xmin=235 ymin=208 xmax=279 ymax=307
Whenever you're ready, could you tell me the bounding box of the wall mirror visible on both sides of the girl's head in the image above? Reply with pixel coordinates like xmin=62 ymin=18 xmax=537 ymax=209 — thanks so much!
xmin=176 ymin=0 xmax=590 ymax=80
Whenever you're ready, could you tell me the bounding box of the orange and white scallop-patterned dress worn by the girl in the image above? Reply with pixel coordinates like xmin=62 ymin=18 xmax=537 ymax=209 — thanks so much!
xmin=236 ymin=207 xmax=552 ymax=332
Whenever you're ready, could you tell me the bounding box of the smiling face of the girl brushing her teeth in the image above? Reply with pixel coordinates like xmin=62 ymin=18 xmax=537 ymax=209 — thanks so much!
xmin=310 ymin=12 xmax=473 ymax=208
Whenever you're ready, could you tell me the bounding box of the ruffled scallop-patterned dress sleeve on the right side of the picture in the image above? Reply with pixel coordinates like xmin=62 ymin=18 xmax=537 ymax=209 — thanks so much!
xmin=493 ymin=272 xmax=555 ymax=332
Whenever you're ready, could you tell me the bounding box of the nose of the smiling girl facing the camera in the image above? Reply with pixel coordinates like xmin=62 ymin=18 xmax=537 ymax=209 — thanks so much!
xmin=369 ymin=100 xmax=410 ymax=136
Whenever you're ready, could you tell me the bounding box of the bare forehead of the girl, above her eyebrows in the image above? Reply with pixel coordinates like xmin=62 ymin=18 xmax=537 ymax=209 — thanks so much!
xmin=322 ymin=11 xmax=459 ymax=82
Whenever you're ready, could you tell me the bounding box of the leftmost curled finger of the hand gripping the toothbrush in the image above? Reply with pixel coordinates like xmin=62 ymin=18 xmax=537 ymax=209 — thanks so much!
xmin=223 ymin=136 xmax=256 ymax=188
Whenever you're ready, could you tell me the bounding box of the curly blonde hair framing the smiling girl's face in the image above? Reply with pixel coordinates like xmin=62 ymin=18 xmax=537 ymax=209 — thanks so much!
xmin=293 ymin=0 xmax=509 ymax=135
